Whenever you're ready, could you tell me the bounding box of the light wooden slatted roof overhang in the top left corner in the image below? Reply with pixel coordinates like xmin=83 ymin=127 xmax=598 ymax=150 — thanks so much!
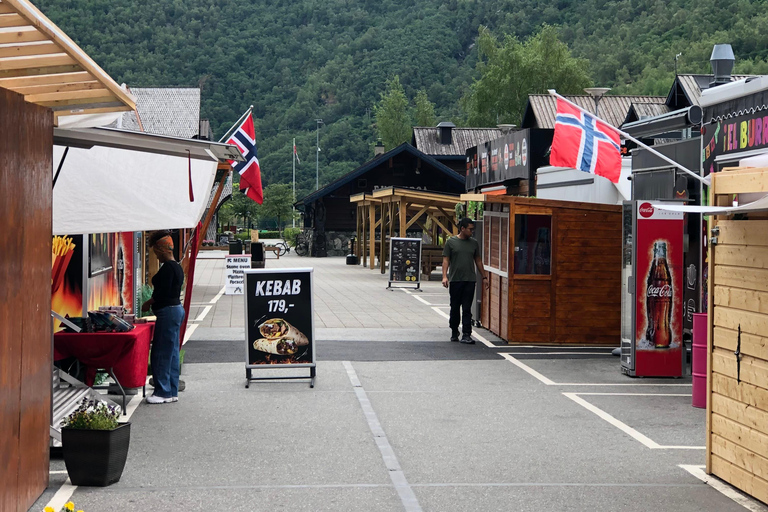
xmin=0 ymin=0 xmax=136 ymax=120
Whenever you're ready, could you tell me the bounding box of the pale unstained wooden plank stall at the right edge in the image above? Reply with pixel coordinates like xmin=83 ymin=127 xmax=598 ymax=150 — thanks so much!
xmin=706 ymin=168 xmax=768 ymax=503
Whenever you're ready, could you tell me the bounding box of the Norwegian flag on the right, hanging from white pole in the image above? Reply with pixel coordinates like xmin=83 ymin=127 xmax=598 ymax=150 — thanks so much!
xmin=549 ymin=98 xmax=621 ymax=183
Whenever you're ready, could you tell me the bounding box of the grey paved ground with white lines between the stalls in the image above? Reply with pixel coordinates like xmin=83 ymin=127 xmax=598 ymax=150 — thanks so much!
xmin=33 ymin=253 xmax=768 ymax=512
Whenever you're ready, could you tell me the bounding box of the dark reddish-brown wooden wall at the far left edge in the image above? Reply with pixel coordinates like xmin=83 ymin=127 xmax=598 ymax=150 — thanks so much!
xmin=0 ymin=88 xmax=53 ymax=511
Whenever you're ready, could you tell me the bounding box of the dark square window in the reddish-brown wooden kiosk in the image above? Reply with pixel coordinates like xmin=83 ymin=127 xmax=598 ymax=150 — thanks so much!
xmin=515 ymin=215 xmax=552 ymax=275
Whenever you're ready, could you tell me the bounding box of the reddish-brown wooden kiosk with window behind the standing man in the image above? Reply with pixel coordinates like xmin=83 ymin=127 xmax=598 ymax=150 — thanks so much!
xmin=461 ymin=194 xmax=621 ymax=346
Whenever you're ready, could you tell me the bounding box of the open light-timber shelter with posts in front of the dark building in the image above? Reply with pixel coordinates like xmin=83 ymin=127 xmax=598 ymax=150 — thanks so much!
xmin=349 ymin=187 xmax=461 ymax=275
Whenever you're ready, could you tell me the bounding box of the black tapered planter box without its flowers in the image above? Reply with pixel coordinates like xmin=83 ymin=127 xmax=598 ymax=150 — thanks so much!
xmin=61 ymin=422 xmax=131 ymax=487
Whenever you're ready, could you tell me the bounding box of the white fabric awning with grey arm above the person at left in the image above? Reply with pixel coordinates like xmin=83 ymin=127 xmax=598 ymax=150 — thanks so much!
xmin=53 ymin=128 xmax=243 ymax=235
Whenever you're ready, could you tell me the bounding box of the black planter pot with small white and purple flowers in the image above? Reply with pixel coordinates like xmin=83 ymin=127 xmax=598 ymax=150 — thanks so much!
xmin=61 ymin=398 xmax=131 ymax=487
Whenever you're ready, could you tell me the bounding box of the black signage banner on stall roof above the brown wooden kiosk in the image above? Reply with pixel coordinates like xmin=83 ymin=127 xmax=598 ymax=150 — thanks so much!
xmin=467 ymin=129 xmax=531 ymax=190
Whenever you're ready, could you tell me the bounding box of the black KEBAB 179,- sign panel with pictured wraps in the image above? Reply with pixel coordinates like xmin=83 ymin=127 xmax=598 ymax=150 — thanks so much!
xmin=245 ymin=268 xmax=315 ymax=368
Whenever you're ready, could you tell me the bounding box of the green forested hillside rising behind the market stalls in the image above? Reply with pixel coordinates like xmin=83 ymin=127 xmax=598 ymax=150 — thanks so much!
xmin=35 ymin=0 xmax=768 ymax=197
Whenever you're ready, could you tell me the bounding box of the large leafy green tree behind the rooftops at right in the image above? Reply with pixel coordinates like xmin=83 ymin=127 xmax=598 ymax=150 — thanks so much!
xmin=462 ymin=25 xmax=592 ymax=126
